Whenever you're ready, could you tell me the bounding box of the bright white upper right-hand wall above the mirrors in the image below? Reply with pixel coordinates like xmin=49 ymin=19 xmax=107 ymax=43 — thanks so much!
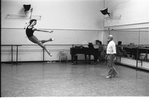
xmin=105 ymin=0 xmax=149 ymax=28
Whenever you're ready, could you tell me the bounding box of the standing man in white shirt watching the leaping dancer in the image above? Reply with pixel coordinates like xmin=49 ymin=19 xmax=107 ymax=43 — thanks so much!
xmin=106 ymin=35 xmax=118 ymax=78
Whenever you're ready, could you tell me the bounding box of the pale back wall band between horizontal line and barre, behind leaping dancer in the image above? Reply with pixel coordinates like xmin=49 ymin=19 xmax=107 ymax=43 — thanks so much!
xmin=1 ymin=29 xmax=102 ymax=44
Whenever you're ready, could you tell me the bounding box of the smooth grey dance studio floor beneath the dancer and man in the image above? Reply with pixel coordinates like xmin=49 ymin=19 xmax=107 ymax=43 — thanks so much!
xmin=1 ymin=63 xmax=149 ymax=97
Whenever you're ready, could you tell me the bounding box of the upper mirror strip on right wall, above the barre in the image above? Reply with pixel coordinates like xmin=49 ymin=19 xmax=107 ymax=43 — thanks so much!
xmin=103 ymin=29 xmax=149 ymax=45
